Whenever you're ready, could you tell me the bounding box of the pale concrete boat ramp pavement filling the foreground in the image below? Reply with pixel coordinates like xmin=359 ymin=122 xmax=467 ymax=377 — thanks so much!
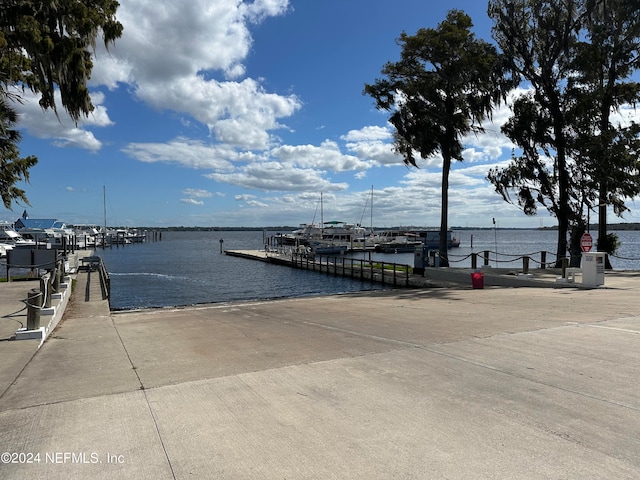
xmin=0 ymin=270 xmax=640 ymax=479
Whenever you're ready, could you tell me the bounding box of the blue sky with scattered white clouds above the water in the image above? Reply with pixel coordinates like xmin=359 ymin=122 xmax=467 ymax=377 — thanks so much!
xmin=0 ymin=0 xmax=640 ymax=228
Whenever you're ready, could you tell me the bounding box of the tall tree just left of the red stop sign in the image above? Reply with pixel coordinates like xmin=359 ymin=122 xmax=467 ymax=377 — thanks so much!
xmin=487 ymin=0 xmax=584 ymax=266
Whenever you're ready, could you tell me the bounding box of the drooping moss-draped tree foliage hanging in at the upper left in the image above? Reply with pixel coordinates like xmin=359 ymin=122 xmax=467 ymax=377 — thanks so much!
xmin=0 ymin=0 xmax=122 ymax=205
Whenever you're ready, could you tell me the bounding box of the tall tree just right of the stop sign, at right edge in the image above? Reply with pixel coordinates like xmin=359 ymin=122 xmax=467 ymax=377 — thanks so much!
xmin=571 ymin=0 xmax=640 ymax=268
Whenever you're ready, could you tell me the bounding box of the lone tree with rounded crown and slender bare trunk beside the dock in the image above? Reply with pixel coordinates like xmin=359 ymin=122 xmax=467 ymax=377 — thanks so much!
xmin=364 ymin=10 xmax=507 ymax=266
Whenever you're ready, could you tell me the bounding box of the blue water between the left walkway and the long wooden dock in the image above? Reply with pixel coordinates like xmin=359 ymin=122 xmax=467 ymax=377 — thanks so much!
xmin=96 ymin=231 xmax=382 ymax=309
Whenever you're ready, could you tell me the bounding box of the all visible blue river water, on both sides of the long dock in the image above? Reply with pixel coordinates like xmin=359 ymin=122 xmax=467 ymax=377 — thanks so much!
xmin=96 ymin=230 xmax=640 ymax=309
